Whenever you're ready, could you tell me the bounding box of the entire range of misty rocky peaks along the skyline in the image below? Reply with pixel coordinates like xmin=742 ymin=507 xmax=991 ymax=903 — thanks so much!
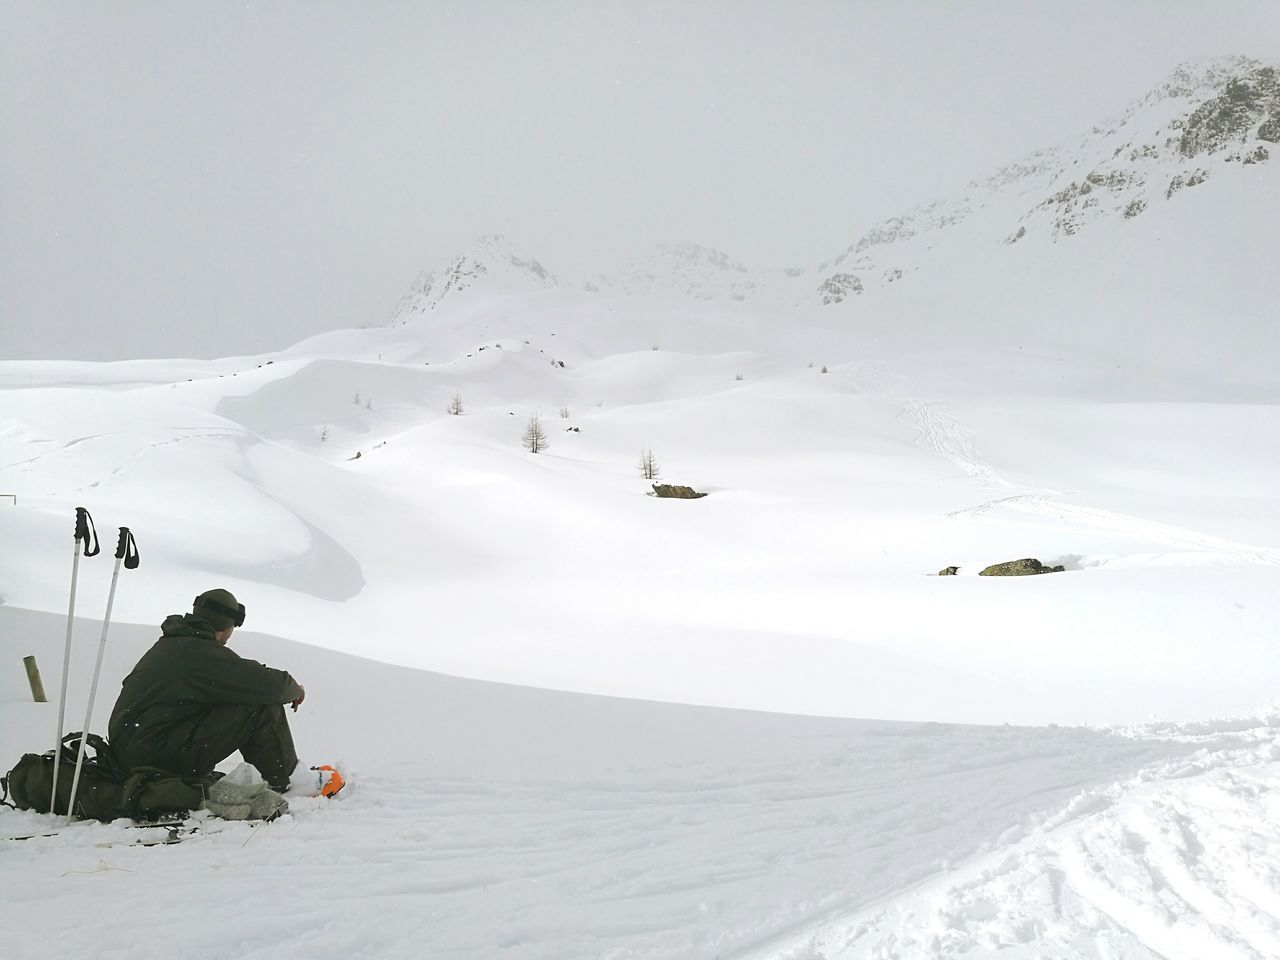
xmin=392 ymin=58 xmax=1280 ymax=313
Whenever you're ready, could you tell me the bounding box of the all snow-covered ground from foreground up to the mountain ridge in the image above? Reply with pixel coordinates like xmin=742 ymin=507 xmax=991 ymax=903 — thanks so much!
xmin=0 ymin=62 xmax=1280 ymax=960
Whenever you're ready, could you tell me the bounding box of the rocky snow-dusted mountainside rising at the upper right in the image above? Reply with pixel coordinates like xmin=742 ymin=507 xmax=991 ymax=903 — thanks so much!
xmin=819 ymin=58 xmax=1280 ymax=287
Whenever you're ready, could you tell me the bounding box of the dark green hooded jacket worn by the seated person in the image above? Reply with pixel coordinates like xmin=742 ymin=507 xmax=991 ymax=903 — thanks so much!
xmin=108 ymin=613 xmax=302 ymax=765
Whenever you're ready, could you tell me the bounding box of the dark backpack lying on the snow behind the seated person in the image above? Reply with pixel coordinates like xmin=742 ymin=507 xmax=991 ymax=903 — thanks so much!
xmin=0 ymin=733 xmax=205 ymax=822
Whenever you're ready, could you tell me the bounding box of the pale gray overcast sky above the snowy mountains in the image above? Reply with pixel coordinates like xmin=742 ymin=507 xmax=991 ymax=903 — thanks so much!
xmin=0 ymin=0 xmax=1280 ymax=360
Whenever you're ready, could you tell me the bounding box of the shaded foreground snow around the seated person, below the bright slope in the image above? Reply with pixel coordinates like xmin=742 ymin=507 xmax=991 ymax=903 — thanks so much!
xmin=0 ymin=605 xmax=1280 ymax=960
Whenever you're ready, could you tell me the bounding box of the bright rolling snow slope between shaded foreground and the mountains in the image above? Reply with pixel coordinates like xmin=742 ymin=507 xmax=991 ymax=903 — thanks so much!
xmin=0 ymin=335 xmax=1277 ymax=722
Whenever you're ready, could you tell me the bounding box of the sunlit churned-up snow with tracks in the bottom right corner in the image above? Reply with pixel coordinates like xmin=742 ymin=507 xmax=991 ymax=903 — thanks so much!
xmin=737 ymin=728 xmax=1280 ymax=960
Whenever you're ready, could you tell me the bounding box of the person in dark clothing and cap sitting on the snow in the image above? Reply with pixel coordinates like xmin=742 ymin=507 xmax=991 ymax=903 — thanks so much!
xmin=108 ymin=590 xmax=306 ymax=819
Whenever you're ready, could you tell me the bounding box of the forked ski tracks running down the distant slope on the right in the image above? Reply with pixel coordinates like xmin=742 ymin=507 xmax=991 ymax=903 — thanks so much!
xmin=846 ymin=361 xmax=1280 ymax=566
